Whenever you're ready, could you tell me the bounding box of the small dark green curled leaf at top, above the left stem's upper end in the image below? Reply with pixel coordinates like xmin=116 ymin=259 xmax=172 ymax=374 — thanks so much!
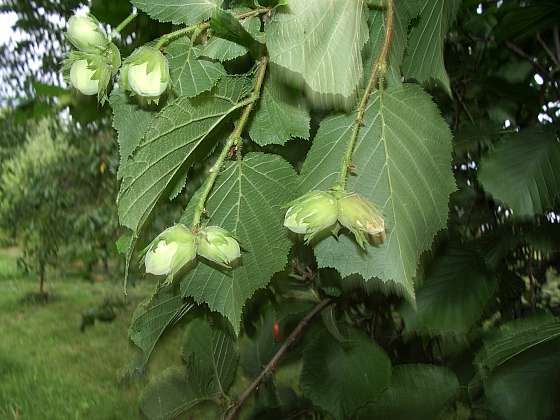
xmin=210 ymin=9 xmax=264 ymax=58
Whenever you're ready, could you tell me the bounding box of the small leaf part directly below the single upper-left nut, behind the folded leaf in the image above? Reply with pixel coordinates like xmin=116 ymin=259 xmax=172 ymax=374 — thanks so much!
xmin=109 ymin=89 xmax=155 ymax=171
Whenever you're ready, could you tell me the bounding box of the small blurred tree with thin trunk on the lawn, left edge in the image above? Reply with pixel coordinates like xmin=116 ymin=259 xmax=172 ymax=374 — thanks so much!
xmin=0 ymin=121 xmax=76 ymax=292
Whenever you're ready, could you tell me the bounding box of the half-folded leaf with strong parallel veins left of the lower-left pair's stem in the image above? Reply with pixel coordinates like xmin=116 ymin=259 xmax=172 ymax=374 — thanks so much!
xmin=118 ymin=77 xmax=252 ymax=232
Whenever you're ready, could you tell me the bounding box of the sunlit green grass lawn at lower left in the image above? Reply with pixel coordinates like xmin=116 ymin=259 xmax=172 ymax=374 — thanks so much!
xmin=0 ymin=250 xmax=178 ymax=420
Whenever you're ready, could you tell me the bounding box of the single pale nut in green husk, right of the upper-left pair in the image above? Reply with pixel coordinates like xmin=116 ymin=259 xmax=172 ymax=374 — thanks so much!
xmin=122 ymin=46 xmax=170 ymax=102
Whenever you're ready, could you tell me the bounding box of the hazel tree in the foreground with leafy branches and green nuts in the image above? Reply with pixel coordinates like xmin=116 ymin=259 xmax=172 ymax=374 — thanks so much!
xmin=58 ymin=0 xmax=559 ymax=419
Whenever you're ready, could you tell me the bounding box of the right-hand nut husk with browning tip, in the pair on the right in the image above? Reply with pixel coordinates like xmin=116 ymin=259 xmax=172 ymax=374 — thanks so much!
xmin=338 ymin=193 xmax=385 ymax=248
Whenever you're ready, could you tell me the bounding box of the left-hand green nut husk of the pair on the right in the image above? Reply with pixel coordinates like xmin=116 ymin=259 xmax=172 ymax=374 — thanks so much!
xmin=284 ymin=191 xmax=338 ymax=241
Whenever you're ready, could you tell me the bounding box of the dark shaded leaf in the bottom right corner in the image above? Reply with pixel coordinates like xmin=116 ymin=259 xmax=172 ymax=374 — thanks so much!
xmin=477 ymin=316 xmax=560 ymax=420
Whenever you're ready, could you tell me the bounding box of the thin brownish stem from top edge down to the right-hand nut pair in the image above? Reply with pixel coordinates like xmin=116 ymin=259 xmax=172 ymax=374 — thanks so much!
xmin=336 ymin=0 xmax=394 ymax=190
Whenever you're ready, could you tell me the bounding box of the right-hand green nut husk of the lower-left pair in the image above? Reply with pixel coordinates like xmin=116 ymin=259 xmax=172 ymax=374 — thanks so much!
xmin=198 ymin=226 xmax=241 ymax=268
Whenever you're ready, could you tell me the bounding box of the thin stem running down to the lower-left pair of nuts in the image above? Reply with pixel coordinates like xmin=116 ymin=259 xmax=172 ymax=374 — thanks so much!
xmin=192 ymin=56 xmax=268 ymax=227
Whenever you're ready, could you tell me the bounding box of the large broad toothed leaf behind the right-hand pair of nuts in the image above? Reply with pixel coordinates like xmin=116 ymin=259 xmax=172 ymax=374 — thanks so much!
xmin=300 ymin=85 xmax=455 ymax=300
